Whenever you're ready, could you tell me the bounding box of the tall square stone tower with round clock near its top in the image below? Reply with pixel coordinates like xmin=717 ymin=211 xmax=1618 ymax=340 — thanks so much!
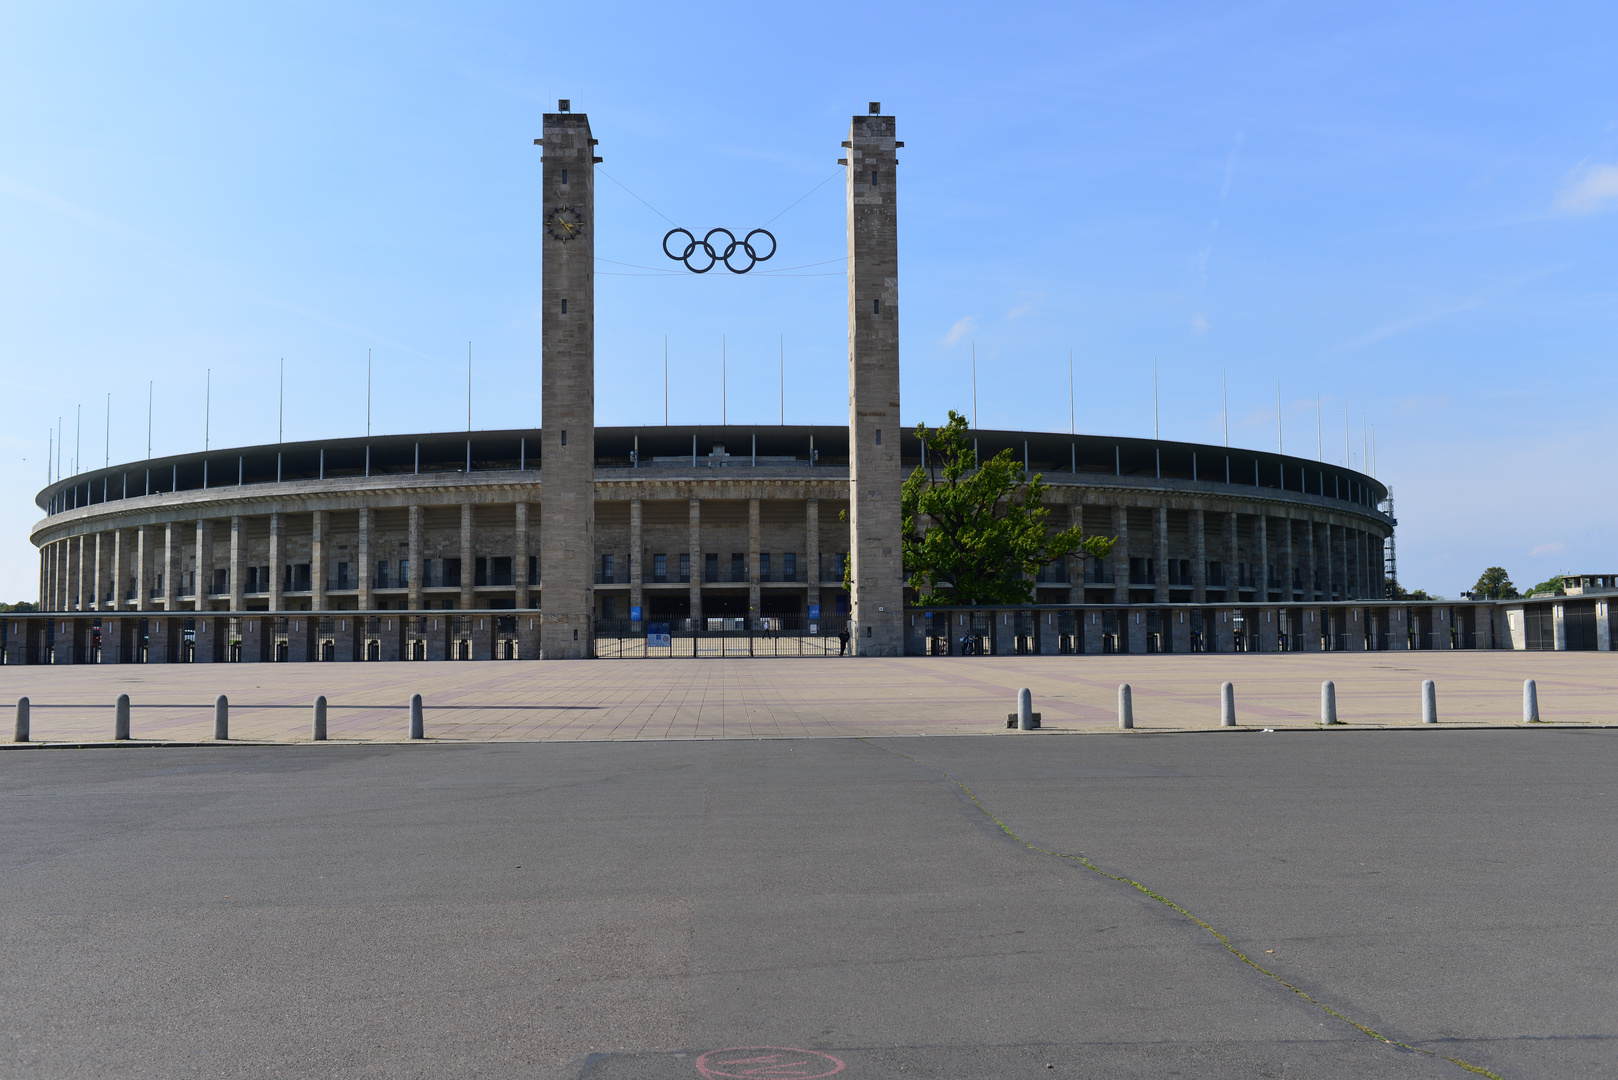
xmin=539 ymin=100 xmax=600 ymax=661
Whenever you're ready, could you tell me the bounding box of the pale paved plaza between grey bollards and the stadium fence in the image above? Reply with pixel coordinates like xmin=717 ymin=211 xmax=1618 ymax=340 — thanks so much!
xmin=0 ymin=653 xmax=1618 ymax=742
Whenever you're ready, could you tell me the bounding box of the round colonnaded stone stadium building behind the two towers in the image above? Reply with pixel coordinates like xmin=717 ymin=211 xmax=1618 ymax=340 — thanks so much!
xmin=12 ymin=426 xmax=1391 ymax=661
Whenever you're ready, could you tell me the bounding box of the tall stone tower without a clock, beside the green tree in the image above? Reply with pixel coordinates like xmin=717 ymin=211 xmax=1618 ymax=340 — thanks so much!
xmin=841 ymin=102 xmax=904 ymax=656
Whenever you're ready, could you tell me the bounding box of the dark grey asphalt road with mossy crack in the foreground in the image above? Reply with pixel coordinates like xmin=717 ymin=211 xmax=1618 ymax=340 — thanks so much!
xmin=0 ymin=730 xmax=1618 ymax=1080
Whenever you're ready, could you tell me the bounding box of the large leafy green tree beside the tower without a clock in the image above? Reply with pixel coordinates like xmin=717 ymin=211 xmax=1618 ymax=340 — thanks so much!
xmin=900 ymin=410 xmax=1116 ymax=604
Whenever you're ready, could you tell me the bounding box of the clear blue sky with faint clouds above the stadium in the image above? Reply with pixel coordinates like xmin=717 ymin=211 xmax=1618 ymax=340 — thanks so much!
xmin=0 ymin=2 xmax=1618 ymax=599
